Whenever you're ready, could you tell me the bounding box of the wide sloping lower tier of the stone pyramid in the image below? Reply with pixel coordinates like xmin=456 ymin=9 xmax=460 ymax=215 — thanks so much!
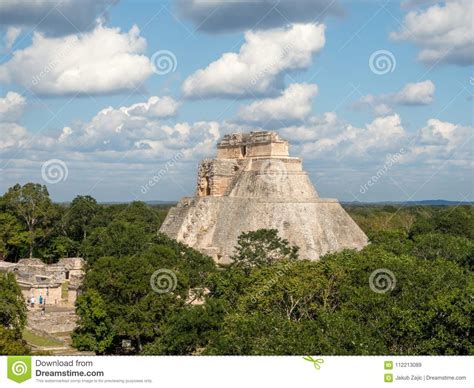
xmin=160 ymin=197 xmax=367 ymax=264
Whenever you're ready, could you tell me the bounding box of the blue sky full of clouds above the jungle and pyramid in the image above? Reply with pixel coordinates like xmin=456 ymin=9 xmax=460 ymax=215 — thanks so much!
xmin=0 ymin=0 xmax=474 ymax=202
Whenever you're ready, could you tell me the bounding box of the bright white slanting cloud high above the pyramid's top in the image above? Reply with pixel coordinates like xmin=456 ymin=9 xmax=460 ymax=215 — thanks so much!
xmin=183 ymin=24 xmax=325 ymax=97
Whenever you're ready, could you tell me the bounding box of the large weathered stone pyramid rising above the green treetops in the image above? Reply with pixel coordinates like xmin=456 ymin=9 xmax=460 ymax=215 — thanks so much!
xmin=160 ymin=131 xmax=367 ymax=264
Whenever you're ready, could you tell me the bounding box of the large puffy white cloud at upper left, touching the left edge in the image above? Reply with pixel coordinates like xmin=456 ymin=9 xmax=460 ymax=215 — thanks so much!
xmin=0 ymin=25 xmax=153 ymax=95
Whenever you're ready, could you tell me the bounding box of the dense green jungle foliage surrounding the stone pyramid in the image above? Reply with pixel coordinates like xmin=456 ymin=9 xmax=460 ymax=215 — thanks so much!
xmin=0 ymin=183 xmax=474 ymax=355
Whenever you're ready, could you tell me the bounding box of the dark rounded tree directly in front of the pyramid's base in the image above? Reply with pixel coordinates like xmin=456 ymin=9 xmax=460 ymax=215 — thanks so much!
xmin=231 ymin=229 xmax=299 ymax=268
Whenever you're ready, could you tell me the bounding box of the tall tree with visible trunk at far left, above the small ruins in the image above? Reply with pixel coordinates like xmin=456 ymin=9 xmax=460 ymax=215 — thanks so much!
xmin=4 ymin=183 xmax=53 ymax=258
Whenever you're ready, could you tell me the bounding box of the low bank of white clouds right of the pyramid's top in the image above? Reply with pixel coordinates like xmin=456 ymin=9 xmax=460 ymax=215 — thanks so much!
xmin=279 ymin=112 xmax=474 ymax=171
